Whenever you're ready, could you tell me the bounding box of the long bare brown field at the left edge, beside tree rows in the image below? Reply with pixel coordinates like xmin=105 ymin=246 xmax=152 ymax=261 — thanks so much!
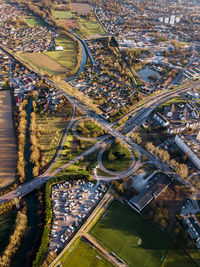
xmin=0 ymin=91 xmax=17 ymax=188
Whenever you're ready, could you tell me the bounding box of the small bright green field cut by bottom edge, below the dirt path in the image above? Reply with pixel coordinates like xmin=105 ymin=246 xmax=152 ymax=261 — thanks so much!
xmin=61 ymin=240 xmax=113 ymax=267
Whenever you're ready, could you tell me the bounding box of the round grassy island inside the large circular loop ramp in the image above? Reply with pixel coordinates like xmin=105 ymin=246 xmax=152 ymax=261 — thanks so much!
xmin=102 ymin=143 xmax=132 ymax=172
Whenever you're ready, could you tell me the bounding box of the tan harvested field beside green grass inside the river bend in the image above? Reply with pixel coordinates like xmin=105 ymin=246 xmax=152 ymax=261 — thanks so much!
xmin=20 ymin=53 xmax=67 ymax=75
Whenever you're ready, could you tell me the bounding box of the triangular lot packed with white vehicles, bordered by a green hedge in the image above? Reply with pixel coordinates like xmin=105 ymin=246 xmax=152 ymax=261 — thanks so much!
xmin=49 ymin=180 xmax=105 ymax=252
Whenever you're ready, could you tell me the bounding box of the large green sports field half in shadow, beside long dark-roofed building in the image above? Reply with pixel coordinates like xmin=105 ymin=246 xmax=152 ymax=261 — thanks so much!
xmin=91 ymin=201 xmax=170 ymax=267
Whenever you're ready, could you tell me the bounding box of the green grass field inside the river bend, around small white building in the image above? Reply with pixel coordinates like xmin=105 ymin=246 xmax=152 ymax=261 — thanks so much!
xmin=44 ymin=35 xmax=77 ymax=70
